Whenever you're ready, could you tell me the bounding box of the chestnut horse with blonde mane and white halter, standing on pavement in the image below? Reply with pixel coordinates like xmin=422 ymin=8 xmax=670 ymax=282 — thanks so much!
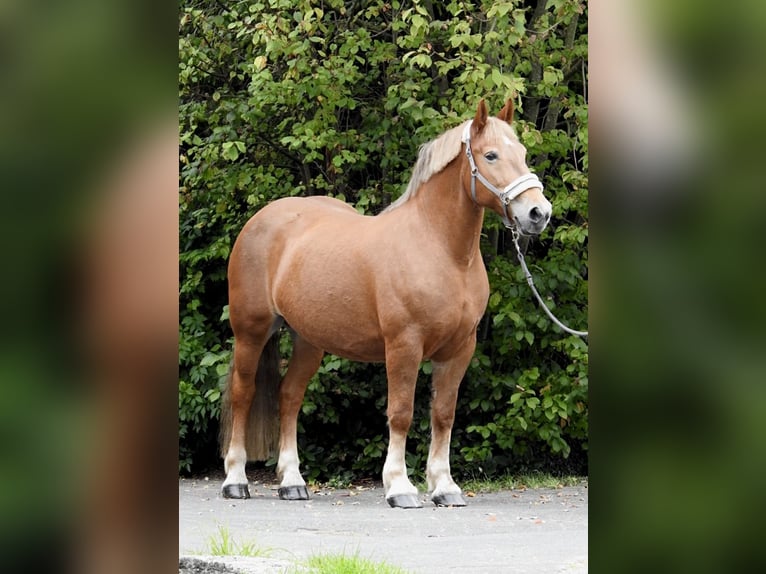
xmin=221 ymin=99 xmax=551 ymax=508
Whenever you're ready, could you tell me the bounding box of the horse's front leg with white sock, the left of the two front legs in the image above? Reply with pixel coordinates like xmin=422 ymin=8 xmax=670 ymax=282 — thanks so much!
xmin=383 ymin=342 xmax=422 ymax=508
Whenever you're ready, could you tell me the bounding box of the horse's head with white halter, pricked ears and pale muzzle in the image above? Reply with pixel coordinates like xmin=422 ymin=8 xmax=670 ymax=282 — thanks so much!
xmin=463 ymin=100 xmax=551 ymax=235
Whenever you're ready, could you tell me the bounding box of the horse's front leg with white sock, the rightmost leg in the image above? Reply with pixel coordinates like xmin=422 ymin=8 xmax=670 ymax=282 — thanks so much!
xmin=426 ymin=333 xmax=476 ymax=506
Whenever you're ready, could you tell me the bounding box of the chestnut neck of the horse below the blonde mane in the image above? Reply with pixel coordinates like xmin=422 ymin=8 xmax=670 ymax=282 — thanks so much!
xmin=412 ymin=161 xmax=484 ymax=265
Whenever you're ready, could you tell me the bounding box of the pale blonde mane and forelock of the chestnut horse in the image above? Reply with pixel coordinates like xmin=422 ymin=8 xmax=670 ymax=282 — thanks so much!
xmin=383 ymin=117 xmax=518 ymax=213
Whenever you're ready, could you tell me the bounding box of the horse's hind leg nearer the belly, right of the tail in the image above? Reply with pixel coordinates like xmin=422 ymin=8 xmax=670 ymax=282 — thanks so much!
xmin=277 ymin=334 xmax=324 ymax=500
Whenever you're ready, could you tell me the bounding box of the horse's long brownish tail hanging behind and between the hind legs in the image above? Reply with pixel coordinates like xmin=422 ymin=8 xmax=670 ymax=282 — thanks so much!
xmin=219 ymin=331 xmax=280 ymax=460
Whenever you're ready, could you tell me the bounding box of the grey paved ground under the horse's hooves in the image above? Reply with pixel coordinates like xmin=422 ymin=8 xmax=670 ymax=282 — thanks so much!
xmin=178 ymin=479 xmax=588 ymax=574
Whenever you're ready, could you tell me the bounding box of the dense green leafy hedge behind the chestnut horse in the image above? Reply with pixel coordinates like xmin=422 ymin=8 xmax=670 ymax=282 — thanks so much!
xmin=179 ymin=0 xmax=588 ymax=480
